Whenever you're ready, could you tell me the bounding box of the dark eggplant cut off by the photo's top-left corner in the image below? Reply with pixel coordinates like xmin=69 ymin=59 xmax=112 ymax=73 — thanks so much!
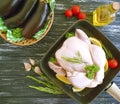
xmin=0 ymin=0 xmax=23 ymax=18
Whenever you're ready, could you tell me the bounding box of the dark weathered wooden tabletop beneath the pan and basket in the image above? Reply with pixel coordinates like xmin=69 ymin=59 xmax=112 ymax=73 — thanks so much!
xmin=0 ymin=0 xmax=120 ymax=104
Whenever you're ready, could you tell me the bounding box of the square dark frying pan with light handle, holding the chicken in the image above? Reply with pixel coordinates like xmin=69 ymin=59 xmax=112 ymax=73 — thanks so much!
xmin=40 ymin=20 xmax=120 ymax=104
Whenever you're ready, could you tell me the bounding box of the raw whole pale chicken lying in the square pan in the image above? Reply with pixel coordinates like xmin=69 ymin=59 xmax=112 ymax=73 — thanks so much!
xmin=48 ymin=29 xmax=106 ymax=89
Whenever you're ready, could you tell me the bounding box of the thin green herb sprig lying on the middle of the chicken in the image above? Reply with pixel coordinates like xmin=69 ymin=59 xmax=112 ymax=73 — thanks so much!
xmin=62 ymin=52 xmax=83 ymax=64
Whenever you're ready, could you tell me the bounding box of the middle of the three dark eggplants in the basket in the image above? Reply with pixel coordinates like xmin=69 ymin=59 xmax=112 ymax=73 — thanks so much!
xmin=5 ymin=0 xmax=37 ymax=28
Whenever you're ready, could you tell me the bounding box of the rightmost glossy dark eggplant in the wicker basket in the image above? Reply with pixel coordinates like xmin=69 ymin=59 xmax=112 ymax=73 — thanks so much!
xmin=22 ymin=1 xmax=50 ymax=39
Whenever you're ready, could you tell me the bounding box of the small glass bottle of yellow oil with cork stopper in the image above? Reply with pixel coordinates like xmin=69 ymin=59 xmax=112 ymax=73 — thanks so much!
xmin=93 ymin=2 xmax=120 ymax=26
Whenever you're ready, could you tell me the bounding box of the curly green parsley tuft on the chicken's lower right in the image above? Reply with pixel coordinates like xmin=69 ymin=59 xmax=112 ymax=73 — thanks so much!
xmin=85 ymin=64 xmax=100 ymax=79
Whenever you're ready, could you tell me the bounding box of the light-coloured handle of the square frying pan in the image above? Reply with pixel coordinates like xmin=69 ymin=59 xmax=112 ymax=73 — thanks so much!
xmin=105 ymin=82 xmax=120 ymax=102
